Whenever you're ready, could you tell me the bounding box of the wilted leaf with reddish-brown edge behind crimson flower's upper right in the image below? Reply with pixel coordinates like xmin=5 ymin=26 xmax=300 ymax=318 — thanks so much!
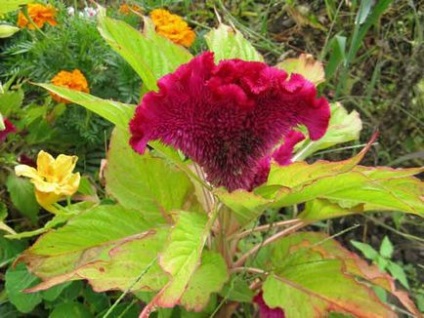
xmin=276 ymin=53 xmax=325 ymax=85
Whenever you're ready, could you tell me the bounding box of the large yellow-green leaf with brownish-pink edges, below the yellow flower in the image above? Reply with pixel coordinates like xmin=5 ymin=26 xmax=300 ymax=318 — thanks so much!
xmin=20 ymin=205 xmax=168 ymax=291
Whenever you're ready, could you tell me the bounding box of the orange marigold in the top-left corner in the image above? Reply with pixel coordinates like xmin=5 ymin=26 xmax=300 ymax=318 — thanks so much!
xmin=17 ymin=3 xmax=57 ymax=30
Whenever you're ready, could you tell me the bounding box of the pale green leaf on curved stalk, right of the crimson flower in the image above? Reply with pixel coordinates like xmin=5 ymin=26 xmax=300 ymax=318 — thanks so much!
xmin=294 ymin=103 xmax=362 ymax=160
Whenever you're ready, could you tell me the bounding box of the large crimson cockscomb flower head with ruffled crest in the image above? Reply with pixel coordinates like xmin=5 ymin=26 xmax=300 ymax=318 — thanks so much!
xmin=130 ymin=52 xmax=330 ymax=191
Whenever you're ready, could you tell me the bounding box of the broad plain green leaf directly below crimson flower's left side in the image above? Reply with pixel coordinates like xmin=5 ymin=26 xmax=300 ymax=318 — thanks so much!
xmin=105 ymin=129 xmax=194 ymax=223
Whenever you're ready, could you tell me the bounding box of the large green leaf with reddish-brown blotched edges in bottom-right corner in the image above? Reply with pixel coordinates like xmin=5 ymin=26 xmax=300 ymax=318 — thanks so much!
xmin=262 ymin=233 xmax=418 ymax=317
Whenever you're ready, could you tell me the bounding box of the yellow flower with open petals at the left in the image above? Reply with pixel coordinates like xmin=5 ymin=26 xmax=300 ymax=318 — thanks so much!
xmin=15 ymin=150 xmax=80 ymax=213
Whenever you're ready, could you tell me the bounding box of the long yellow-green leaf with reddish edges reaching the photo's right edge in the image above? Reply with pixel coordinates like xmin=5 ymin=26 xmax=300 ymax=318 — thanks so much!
xmin=217 ymin=151 xmax=424 ymax=221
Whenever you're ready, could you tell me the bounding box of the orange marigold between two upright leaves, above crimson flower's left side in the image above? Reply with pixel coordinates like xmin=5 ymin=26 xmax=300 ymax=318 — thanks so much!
xmin=150 ymin=9 xmax=196 ymax=47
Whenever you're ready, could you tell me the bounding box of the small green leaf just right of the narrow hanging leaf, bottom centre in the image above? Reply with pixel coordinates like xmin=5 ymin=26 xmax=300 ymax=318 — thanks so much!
xmin=180 ymin=251 xmax=228 ymax=311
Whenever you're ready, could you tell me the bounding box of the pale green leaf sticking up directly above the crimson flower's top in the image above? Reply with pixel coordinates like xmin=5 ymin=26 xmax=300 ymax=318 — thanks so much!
xmin=205 ymin=23 xmax=263 ymax=62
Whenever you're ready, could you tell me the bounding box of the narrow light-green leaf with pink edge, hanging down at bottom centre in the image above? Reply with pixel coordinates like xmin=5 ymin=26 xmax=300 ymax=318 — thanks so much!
xmin=153 ymin=211 xmax=209 ymax=307
